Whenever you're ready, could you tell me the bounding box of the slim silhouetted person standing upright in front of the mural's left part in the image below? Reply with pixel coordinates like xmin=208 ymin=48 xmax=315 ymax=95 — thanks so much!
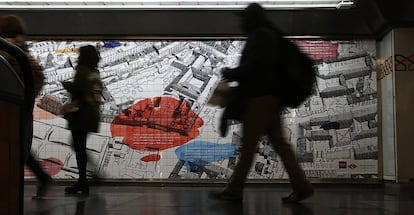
xmin=62 ymin=45 xmax=103 ymax=194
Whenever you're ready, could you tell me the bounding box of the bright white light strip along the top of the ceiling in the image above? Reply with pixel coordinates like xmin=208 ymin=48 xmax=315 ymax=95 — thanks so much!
xmin=0 ymin=0 xmax=355 ymax=9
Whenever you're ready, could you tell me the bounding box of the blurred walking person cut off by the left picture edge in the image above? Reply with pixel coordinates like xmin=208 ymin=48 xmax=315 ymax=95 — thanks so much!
xmin=0 ymin=15 xmax=53 ymax=197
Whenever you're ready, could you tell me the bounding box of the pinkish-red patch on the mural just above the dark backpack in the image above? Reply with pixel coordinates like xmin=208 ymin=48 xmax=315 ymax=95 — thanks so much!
xmin=294 ymin=40 xmax=339 ymax=61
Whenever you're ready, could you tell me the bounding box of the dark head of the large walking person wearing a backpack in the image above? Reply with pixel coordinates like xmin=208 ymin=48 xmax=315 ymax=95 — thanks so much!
xmin=239 ymin=3 xmax=269 ymax=33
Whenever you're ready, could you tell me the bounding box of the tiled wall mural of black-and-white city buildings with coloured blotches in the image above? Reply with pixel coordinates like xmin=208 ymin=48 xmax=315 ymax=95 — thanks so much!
xmin=25 ymin=39 xmax=378 ymax=180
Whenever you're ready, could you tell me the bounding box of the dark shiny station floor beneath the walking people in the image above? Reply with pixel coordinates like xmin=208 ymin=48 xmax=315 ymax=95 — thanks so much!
xmin=23 ymin=184 xmax=414 ymax=215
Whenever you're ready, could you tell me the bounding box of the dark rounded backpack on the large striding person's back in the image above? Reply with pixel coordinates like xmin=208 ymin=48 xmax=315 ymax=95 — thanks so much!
xmin=278 ymin=39 xmax=316 ymax=108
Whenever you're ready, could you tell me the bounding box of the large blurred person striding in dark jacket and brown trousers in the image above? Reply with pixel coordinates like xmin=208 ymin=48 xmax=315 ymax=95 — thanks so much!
xmin=210 ymin=3 xmax=314 ymax=202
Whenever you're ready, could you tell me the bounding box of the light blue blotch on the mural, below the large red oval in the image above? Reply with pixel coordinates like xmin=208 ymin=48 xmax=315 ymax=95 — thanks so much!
xmin=175 ymin=140 xmax=237 ymax=170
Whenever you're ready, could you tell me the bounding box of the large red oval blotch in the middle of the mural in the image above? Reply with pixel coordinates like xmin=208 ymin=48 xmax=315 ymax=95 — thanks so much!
xmin=111 ymin=97 xmax=204 ymax=151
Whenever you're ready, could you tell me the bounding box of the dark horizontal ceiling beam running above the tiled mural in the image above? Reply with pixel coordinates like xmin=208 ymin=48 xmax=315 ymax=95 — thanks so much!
xmin=0 ymin=0 xmax=414 ymax=39
